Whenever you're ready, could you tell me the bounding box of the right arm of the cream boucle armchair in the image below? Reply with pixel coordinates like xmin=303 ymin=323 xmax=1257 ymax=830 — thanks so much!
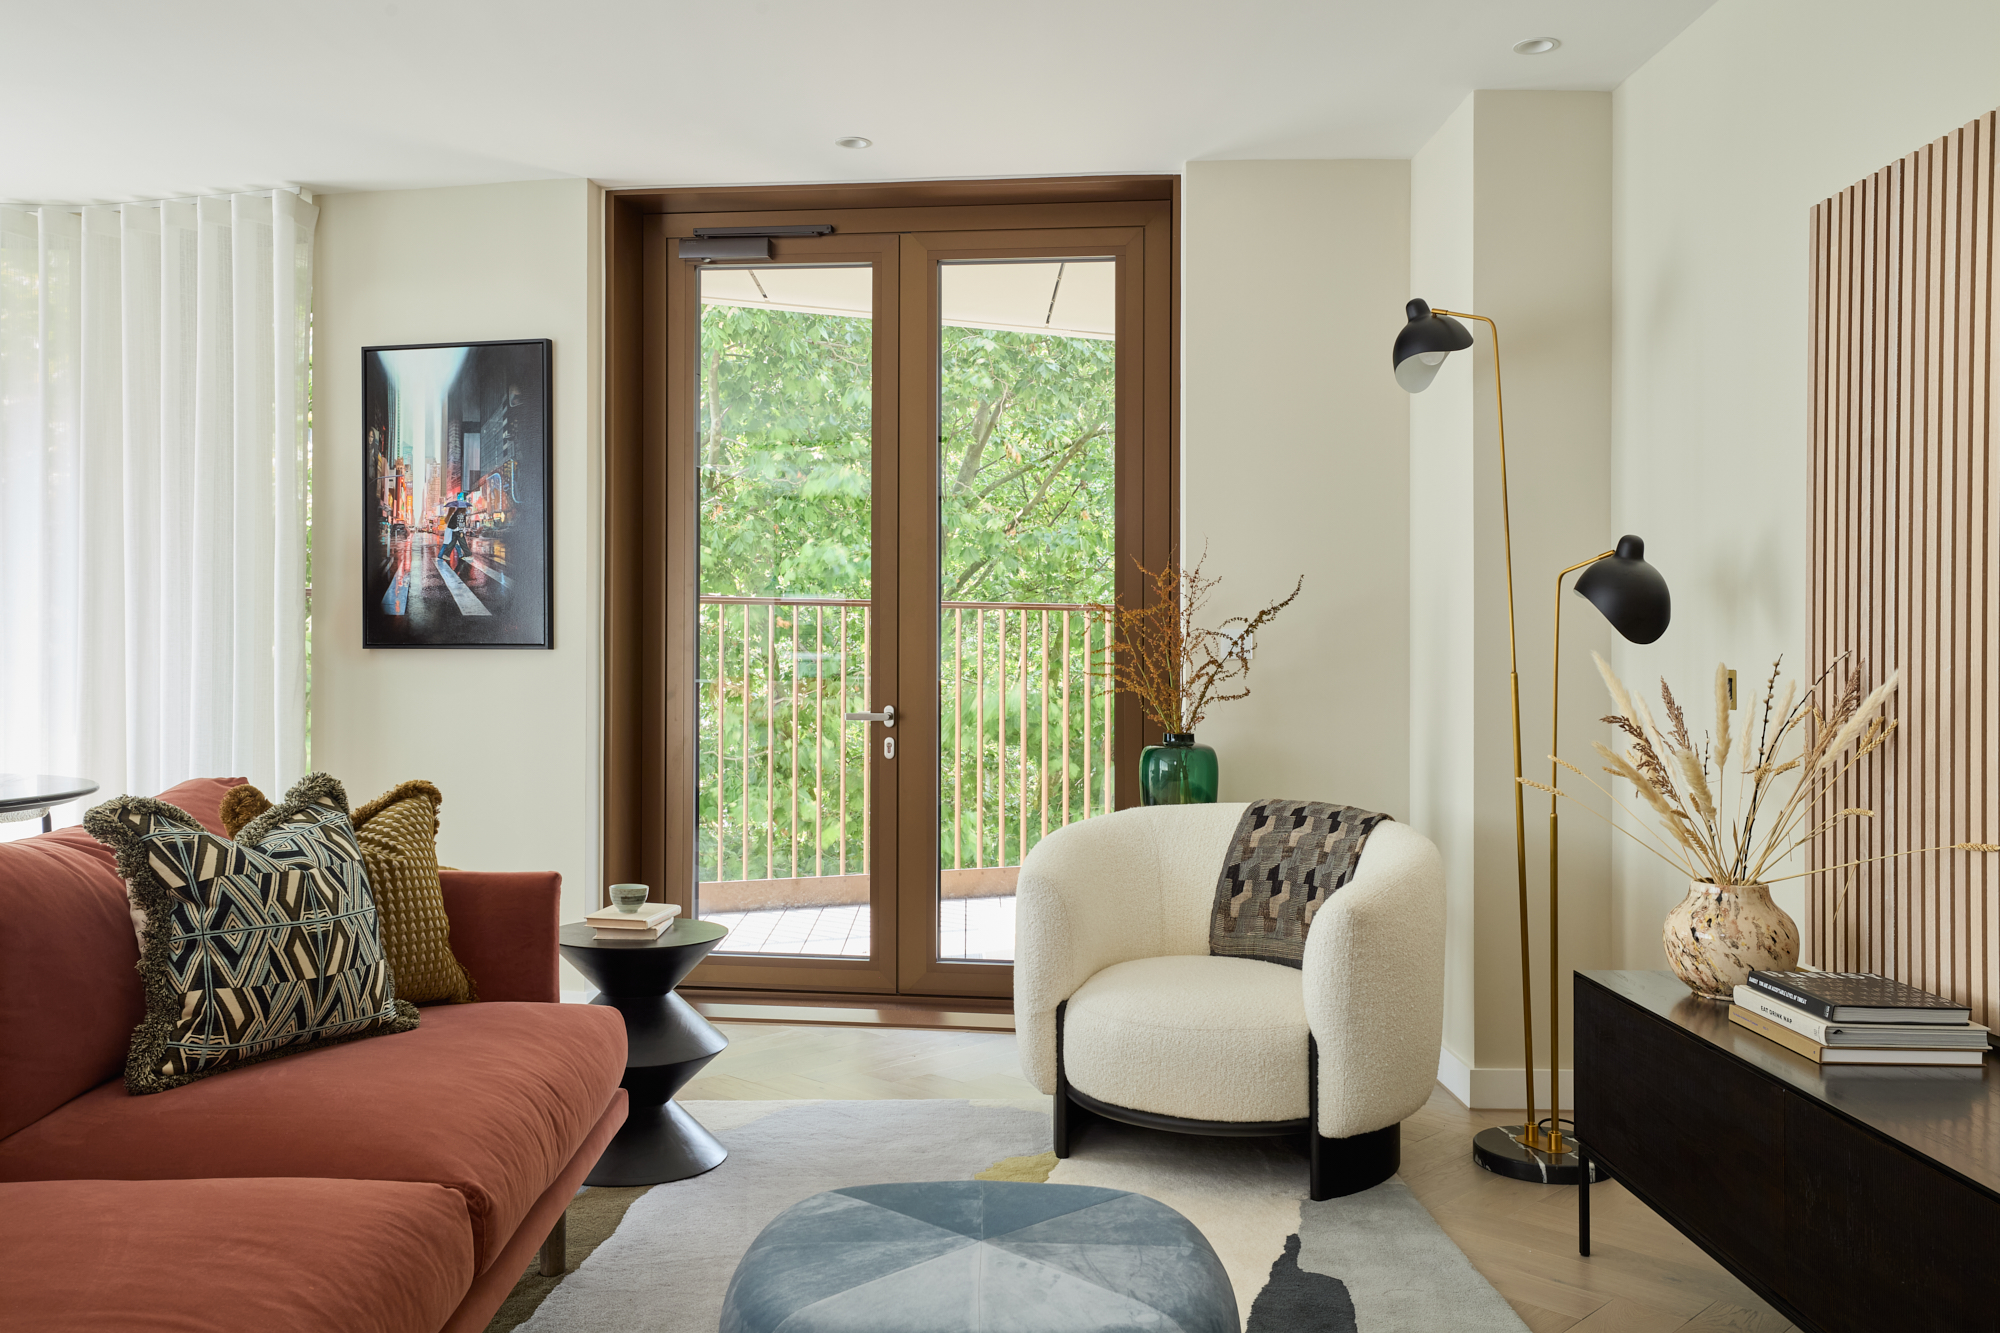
xmin=1302 ymin=823 xmax=1444 ymax=1139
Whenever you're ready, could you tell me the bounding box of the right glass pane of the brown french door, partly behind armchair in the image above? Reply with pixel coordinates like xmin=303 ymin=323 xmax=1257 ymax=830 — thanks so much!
xmin=938 ymin=258 xmax=1118 ymax=961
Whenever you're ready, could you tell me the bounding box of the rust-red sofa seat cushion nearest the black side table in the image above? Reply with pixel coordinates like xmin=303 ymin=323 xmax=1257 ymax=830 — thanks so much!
xmin=0 ymin=1003 xmax=626 ymax=1271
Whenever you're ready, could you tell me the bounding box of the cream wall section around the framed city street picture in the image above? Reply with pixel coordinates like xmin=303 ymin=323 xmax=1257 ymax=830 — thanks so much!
xmin=312 ymin=180 xmax=602 ymax=944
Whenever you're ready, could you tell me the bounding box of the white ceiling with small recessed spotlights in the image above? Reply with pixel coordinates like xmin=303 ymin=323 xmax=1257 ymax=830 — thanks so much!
xmin=0 ymin=0 xmax=1712 ymax=202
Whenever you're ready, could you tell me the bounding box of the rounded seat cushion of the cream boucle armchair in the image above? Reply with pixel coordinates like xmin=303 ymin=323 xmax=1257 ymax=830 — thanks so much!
xmin=1062 ymin=955 xmax=1312 ymax=1121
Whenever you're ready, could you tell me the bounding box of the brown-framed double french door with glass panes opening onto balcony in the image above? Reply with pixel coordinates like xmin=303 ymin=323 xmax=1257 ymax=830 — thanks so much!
xmin=606 ymin=180 xmax=1178 ymax=1003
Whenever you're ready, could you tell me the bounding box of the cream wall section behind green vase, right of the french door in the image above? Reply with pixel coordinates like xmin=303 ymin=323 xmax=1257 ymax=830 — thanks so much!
xmin=1182 ymin=160 xmax=1410 ymax=819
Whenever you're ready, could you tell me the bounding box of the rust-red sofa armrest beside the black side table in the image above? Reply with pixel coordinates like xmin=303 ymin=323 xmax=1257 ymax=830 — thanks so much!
xmin=438 ymin=871 xmax=562 ymax=1005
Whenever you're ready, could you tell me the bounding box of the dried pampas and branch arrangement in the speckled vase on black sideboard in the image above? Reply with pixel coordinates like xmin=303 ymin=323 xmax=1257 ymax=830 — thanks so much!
xmin=1522 ymin=652 xmax=2000 ymax=885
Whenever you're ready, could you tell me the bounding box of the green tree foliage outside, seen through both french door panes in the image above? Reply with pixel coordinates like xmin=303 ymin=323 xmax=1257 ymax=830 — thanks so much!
xmin=698 ymin=296 xmax=1116 ymax=881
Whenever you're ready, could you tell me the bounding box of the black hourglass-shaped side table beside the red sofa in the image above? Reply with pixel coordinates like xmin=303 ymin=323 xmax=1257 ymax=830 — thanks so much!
xmin=560 ymin=921 xmax=730 ymax=1185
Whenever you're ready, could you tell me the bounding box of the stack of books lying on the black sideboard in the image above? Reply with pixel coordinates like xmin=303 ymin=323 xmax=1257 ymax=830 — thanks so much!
xmin=1730 ymin=960 xmax=1986 ymax=1065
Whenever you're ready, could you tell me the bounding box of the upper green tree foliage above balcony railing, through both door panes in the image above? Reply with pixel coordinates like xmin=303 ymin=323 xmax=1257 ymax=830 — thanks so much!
xmin=700 ymin=306 xmax=1116 ymax=602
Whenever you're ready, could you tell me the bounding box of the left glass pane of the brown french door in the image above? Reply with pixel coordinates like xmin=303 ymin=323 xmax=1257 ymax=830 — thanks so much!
xmin=696 ymin=264 xmax=880 ymax=959
